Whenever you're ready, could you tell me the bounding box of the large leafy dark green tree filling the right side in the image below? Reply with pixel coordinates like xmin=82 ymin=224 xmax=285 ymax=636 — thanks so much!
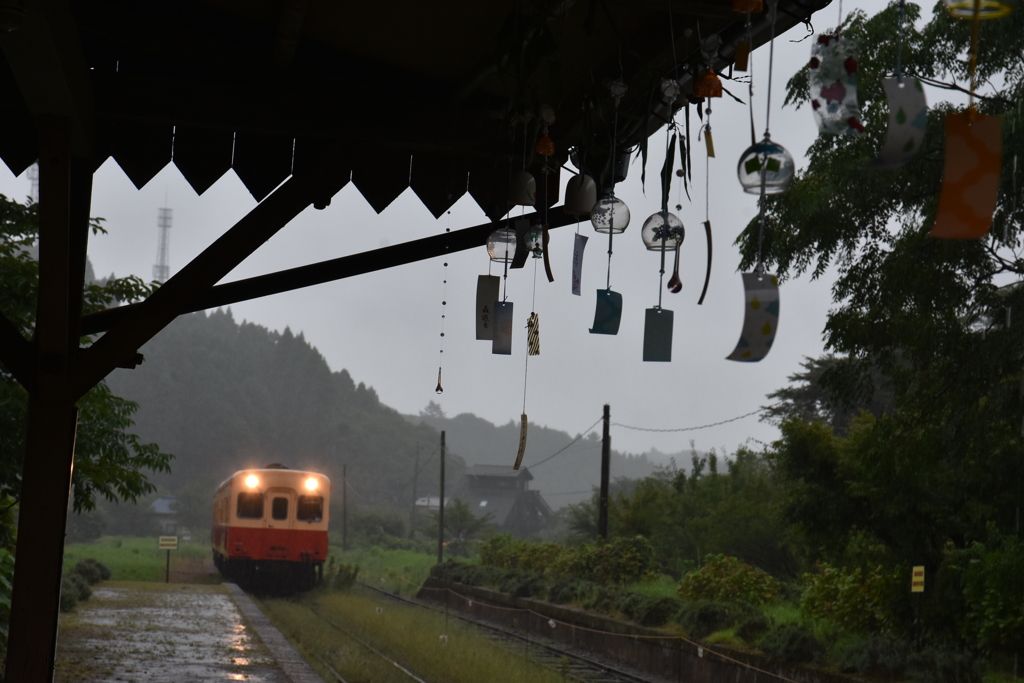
xmin=739 ymin=4 xmax=1024 ymax=651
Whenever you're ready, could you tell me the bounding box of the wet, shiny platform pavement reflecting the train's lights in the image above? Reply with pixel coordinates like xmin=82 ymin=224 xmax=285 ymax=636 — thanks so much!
xmin=55 ymin=582 xmax=323 ymax=683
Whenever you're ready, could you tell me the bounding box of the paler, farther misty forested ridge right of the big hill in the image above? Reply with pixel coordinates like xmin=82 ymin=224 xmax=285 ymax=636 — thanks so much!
xmin=408 ymin=401 xmax=659 ymax=509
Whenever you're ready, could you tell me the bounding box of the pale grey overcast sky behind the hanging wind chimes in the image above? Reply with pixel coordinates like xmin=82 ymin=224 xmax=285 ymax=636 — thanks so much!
xmin=0 ymin=0 xmax=938 ymax=464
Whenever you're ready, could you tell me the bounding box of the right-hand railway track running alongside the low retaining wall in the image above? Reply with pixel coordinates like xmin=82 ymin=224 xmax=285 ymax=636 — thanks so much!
xmin=358 ymin=582 xmax=651 ymax=683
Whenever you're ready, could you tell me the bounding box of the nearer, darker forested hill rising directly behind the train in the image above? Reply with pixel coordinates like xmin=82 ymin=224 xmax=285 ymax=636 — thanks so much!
xmin=109 ymin=310 xmax=456 ymax=507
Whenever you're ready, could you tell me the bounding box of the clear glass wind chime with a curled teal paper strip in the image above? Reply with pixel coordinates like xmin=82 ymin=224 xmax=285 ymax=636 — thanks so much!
xmin=590 ymin=79 xmax=630 ymax=335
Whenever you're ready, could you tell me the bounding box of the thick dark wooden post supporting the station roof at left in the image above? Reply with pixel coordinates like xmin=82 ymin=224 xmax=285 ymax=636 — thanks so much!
xmin=5 ymin=119 xmax=92 ymax=683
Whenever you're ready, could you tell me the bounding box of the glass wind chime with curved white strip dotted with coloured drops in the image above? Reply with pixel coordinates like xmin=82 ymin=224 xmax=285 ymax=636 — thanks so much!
xmin=726 ymin=0 xmax=794 ymax=362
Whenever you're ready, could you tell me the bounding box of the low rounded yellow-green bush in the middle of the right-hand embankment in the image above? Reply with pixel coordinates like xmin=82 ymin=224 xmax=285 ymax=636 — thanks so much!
xmin=679 ymin=555 xmax=781 ymax=605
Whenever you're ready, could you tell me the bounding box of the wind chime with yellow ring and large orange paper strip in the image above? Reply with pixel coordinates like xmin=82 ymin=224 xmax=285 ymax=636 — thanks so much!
xmin=929 ymin=0 xmax=1013 ymax=240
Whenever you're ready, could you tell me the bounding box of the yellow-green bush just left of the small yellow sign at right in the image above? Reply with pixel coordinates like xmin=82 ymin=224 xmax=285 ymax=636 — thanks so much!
xmin=800 ymin=563 xmax=907 ymax=634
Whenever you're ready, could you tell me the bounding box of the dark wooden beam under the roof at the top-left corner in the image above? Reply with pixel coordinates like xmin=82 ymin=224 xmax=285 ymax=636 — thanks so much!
xmin=0 ymin=0 xmax=95 ymax=158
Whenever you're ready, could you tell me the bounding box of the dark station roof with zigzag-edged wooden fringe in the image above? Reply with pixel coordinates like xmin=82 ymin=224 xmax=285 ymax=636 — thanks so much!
xmin=0 ymin=0 xmax=828 ymax=219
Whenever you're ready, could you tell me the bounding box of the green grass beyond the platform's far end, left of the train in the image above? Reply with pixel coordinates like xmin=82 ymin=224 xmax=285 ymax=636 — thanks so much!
xmin=65 ymin=536 xmax=219 ymax=583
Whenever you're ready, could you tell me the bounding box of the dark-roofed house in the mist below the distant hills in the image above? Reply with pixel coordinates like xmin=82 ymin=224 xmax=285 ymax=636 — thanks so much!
xmin=452 ymin=465 xmax=553 ymax=537
